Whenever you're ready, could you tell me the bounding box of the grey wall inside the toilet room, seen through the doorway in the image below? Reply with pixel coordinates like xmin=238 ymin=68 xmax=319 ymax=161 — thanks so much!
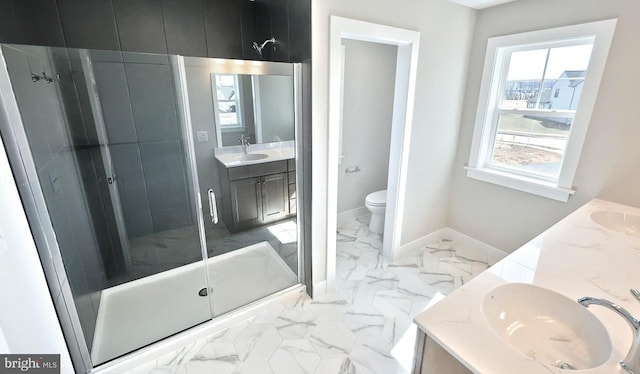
xmin=338 ymin=39 xmax=398 ymax=213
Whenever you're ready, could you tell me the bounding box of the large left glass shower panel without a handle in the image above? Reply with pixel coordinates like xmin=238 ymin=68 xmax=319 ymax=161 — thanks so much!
xmin=2 ymin=45 xmax=212 ymax=366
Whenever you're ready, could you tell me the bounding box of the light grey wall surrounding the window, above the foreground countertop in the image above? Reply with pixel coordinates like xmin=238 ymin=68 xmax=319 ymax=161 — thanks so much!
xmin=449 ymin=0 xmax=640 ymax=252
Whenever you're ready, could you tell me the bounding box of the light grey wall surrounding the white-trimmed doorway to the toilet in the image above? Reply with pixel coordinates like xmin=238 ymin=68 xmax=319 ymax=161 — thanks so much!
xmin=312 ymin=0 xmax=475 ymax=290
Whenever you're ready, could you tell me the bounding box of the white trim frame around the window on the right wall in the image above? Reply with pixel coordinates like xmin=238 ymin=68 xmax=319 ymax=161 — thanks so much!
xmin=466 ymin=19 xmax=617 ymax=202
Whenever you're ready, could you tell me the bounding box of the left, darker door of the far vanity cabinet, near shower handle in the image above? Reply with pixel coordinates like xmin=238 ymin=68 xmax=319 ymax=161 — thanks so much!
xmin=229 ymin=178 xmax=262 ymax=228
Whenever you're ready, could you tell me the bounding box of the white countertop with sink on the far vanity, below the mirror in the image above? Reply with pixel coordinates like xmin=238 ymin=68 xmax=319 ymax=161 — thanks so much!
xmin=215 ymin=141 xmax=296 ymax=168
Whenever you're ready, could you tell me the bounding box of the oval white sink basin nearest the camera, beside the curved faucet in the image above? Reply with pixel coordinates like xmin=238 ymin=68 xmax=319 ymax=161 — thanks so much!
xmin=482 ymin=283 xmax=612 ymax=370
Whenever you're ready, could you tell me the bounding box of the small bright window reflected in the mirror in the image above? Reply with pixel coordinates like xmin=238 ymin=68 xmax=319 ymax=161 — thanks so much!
xmin=214 ymin=74 xmax=243 ymax=129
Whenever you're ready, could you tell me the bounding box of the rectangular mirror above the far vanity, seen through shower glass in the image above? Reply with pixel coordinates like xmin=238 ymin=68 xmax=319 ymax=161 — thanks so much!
xmin=211 ymin=71 xmax=294 ymax=147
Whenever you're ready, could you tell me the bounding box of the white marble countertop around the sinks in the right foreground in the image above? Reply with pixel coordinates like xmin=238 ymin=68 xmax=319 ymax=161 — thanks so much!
xmin=415 ymin=200 xmax=640 ymax=374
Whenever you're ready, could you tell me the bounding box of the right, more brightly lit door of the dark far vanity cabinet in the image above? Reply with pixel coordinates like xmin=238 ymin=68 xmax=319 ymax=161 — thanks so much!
xmin=262 ymin=173 xmax=289 ymax=222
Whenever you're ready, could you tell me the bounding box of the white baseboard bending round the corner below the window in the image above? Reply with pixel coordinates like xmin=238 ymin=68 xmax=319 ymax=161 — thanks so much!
xmin=395 ymin=227 xmax=508 ymax=266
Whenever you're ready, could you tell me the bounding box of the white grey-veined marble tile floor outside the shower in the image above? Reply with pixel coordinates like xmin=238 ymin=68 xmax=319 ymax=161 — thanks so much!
xmin=128 ymin=216 xmax=489 ymax=374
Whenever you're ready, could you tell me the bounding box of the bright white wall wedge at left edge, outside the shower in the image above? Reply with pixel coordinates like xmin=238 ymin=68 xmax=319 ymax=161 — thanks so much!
xmin=0 ymin=135 xmax=73 ymax=373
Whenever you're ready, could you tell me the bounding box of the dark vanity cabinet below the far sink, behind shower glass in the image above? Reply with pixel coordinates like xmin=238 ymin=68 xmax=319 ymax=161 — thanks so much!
xmin=218 ymin=160 xmax=295 ymax=231
